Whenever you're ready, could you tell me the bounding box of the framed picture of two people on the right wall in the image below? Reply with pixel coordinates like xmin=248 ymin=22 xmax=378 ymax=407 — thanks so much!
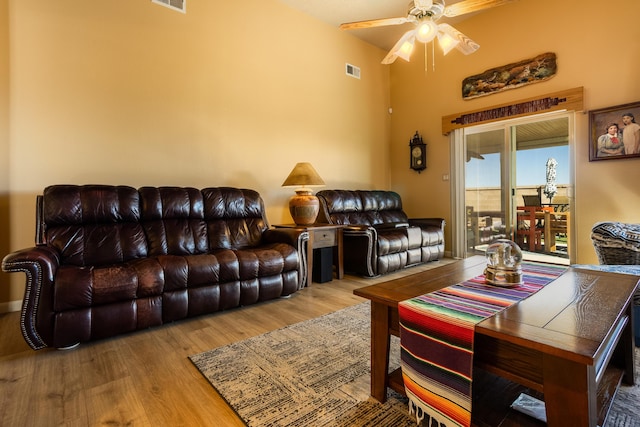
xmin=589 ymin=101 xmax=640 ymax=162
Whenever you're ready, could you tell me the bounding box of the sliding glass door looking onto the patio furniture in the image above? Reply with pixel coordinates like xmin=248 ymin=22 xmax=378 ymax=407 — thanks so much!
xmin=455 ymin=113 xmax=572 ymax=262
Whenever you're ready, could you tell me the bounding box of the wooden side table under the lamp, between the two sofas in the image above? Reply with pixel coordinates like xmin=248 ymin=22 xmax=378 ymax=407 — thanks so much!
xmin=273 ymin=224 xmax=344 ymax=286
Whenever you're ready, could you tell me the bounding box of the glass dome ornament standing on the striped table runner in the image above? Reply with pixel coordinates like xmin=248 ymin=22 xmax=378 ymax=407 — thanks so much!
xmin=484 ymin=239 xmax=523 ymax=287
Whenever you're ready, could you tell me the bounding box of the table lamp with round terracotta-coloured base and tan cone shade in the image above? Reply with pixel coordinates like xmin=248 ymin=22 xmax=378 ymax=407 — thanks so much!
xmin=282 ymin=162 xmax=325 ymax=226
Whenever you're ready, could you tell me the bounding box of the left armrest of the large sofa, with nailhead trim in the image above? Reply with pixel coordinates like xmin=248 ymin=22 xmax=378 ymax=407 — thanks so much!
xmin=2 ymin=246 xmax=60 ymax=350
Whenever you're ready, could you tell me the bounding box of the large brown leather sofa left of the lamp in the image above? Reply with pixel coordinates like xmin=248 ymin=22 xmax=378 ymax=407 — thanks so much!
xmin=2 ymin=185 xmax=308 ymax=349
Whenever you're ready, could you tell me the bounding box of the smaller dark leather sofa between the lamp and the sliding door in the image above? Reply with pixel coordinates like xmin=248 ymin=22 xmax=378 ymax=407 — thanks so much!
xmin=316 ymin=190 xmax=445 ymax=277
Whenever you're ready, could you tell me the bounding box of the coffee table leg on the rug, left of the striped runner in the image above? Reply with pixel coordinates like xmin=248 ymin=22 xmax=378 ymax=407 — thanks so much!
xmin=371 ymin=301 xmax=390 ymax=403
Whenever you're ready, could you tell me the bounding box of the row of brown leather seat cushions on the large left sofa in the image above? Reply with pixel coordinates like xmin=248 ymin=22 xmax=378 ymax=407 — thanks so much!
xmin=53 ymin=243 xmax=298 ymax=314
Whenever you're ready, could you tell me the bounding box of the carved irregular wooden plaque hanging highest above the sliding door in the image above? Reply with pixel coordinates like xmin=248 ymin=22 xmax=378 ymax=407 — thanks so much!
xmin=462 ymin=52 xmax=558 ymax=99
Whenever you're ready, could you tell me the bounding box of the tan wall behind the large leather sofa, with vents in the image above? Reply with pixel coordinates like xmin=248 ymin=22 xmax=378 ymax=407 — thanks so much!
xmin=0 ymin=0 xmax=390 ymax=309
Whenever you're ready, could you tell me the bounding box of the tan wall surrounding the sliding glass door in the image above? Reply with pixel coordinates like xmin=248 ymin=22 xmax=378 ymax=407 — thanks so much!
xmin=391 ymin=0 xmax=640 ymax=263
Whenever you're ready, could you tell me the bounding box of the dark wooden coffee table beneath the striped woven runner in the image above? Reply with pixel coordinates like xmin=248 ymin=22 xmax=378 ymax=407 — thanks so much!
xmin=354 ymin=257 xmax=638 ymax=427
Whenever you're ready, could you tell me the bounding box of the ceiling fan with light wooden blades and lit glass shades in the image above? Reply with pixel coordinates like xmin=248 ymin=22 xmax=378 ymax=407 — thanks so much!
xmin=340 ymin=0 xmax=515 ymax=64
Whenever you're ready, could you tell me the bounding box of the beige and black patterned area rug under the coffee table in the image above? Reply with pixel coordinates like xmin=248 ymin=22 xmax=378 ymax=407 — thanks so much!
xmin=190 ymin=302 xmax=640 ymax=427
